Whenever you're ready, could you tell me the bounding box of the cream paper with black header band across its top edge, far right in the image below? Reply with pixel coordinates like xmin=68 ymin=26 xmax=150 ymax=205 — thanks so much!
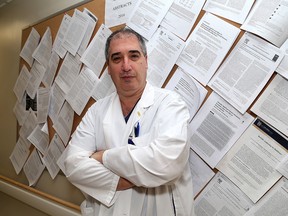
xmin=216 ymin=119 xmax=288 ymax=203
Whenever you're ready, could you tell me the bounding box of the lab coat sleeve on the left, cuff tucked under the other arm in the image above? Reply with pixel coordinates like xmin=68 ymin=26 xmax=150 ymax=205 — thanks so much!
xmin=64 ymin=104 xmax=119 ymax=206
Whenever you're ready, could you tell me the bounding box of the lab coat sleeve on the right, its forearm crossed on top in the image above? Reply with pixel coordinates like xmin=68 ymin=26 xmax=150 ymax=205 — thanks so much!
xmin=103 ymin=96 xmax=189 ymax=187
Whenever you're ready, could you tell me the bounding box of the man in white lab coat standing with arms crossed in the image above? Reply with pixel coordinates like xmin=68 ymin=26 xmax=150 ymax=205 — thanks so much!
xmin=63 ymin=29 xmax=193 ymax=216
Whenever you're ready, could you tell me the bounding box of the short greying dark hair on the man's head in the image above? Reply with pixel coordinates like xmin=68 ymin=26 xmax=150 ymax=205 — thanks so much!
xmin=105 ymin=27 xmax=147 ymax=62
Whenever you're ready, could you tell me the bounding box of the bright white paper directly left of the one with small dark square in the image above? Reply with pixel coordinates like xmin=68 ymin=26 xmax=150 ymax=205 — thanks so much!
xmin=176 ymin=13 xmax=240 ymax=86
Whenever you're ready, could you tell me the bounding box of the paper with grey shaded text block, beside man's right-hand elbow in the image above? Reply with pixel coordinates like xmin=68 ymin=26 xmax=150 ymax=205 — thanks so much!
xmin=188 ymin=92 xmax=254 ymax=168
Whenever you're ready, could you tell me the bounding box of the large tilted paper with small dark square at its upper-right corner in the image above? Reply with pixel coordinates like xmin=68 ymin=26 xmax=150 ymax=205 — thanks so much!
xmin=208 ymin=32 xmax=284 ymax=113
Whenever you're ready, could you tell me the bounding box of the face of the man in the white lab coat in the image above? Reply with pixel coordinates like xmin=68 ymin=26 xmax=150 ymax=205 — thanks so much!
xmin=108 ymin=34 xmax=147 ymax=96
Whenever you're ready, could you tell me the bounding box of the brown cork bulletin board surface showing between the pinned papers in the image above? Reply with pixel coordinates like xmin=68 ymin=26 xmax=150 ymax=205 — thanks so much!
xmin=14 ymin=0 xmax=286 ymax=213
